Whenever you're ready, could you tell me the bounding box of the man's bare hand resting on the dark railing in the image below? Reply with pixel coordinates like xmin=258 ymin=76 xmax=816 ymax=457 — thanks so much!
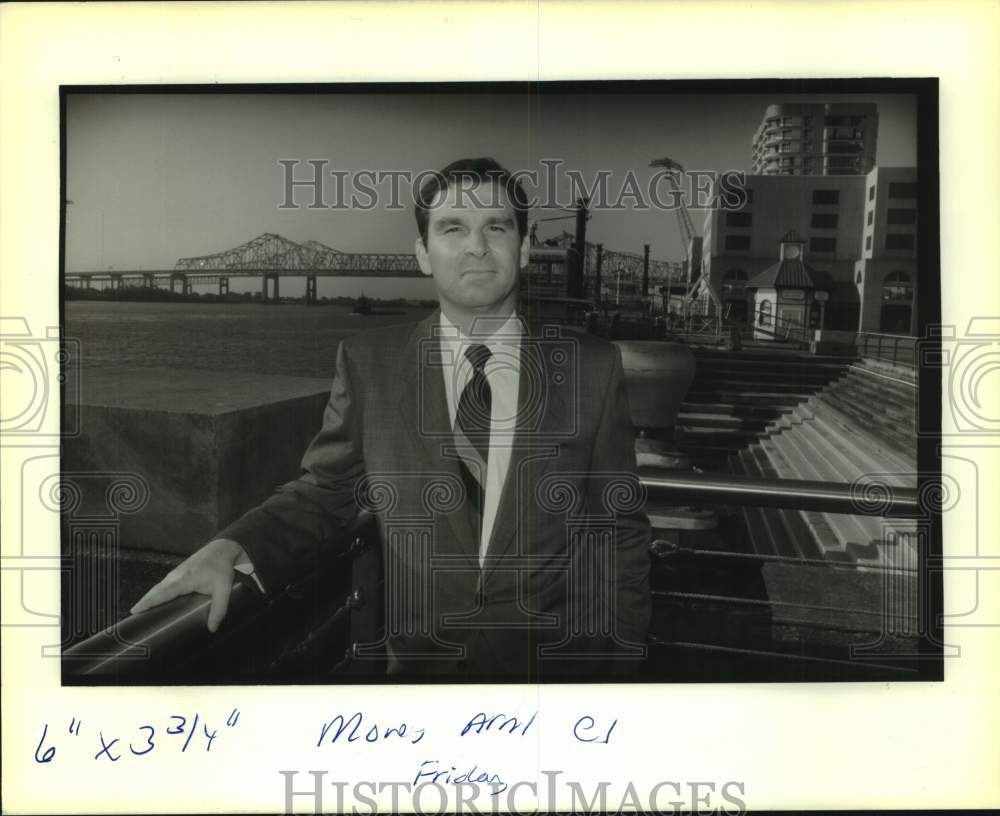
xmin=130 ymin=538 xmax=249 ymax=632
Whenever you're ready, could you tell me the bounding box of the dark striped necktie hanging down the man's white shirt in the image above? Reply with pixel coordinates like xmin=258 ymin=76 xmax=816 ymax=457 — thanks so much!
xmin=455 ymin=344 xmax=493 ymax=549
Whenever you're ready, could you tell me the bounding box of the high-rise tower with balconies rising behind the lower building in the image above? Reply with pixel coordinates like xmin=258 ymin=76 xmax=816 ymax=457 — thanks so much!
xmin=750 ymin=102 xmax=878 ymax=176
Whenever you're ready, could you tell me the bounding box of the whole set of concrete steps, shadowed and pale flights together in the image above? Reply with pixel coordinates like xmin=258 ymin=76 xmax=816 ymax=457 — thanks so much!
xmin=677 ymin=351 xmax=916 ymax=573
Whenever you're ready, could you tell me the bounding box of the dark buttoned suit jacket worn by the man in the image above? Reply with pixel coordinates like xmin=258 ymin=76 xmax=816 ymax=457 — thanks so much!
xmin=219 ymin=312 xmax=651 ymax=680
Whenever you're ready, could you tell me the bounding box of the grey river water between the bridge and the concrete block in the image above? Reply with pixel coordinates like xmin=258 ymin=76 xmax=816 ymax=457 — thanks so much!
xmin=65 ymin=301 xmax=430 ymax=378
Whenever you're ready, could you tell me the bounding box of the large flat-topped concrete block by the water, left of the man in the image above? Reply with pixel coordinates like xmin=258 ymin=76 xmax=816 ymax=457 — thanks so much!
xmin=62 ymin=366 xmax=330 ymax=554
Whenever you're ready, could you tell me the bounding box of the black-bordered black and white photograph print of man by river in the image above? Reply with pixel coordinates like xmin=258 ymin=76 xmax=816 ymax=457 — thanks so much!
xmin=59 ymin=79 xmax=947 ymax=685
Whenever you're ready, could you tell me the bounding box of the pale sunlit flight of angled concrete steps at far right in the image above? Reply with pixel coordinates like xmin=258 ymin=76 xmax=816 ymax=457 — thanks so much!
xmin=727 ymin=362 xmax=917 ymax=571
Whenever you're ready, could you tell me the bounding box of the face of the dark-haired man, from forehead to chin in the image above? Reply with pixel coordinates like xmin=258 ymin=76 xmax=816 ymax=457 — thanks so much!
xmin=416 ymin=180 xmax=529 ymax=315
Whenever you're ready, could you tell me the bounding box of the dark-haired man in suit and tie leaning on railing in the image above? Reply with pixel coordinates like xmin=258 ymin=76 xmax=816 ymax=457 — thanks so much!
xmin=133 ymin=159 xmax=651 ymax=680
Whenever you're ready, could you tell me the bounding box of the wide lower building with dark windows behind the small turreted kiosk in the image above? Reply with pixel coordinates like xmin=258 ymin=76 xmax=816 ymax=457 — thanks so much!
xmin=701 ymin=167 xmax=917 ymax=334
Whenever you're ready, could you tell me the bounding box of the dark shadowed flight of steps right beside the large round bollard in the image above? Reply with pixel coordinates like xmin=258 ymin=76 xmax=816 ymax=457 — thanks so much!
xmin=677 ymin=347 xmax=850 ymax=470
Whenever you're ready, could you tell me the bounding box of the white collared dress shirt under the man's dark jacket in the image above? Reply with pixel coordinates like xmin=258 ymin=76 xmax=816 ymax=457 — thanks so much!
xmin=440 ymin=310 xmax=523 ymax=566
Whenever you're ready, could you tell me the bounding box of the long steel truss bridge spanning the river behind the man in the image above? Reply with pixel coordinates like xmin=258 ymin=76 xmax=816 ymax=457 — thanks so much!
xmin=66 ymin=232 xmax=684 ymax=303
